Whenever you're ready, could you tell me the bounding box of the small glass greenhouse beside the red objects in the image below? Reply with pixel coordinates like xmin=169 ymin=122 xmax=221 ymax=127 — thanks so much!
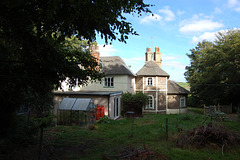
xmin=57 ymin=98 xmax=96 ymax=125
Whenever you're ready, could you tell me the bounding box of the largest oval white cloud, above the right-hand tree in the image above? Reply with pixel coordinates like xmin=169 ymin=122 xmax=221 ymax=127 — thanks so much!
xmin=179 ymin=18 xmax=224 ymax=33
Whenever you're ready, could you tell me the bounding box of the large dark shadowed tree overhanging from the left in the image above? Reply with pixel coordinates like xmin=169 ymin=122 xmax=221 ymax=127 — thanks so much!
xmin=0 ymin=0 xmax=150 ymax=132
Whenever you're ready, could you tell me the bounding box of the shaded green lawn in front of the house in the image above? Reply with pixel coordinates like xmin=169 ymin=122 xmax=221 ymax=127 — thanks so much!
xmin=2 ymin=114 xmax=240 ymax=160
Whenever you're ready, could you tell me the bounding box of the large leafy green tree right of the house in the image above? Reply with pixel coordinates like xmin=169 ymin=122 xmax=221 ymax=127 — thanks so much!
xmin=185 ymin=30 xmax=240 ymax=104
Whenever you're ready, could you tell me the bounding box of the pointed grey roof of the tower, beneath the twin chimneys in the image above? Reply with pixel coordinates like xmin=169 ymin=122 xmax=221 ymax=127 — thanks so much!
xmin=137 ymin=61 xmax=169 ymax=77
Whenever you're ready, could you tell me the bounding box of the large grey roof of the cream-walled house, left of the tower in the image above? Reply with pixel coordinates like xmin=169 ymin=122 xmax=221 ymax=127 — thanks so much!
xmin=100 ymin=56 xmax=135 ymax=76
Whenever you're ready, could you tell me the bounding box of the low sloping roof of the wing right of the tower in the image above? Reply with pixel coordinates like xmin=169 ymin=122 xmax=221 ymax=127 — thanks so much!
xmin=168 ymin=80 xmax=189 ymax=94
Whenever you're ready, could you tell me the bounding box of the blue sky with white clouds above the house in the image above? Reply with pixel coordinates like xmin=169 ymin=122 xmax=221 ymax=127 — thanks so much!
xmin=97 ymin=0 xmax=240 ymax=82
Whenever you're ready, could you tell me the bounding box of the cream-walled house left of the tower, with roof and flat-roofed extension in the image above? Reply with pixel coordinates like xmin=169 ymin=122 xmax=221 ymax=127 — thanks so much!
xmin=54 ymin=47 xmax=135 ymax=119
